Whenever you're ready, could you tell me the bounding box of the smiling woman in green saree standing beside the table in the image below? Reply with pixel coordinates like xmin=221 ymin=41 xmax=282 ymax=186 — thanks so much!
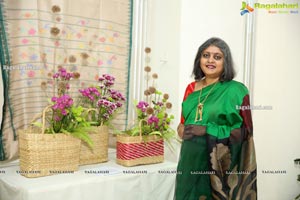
xmin=175 ymin=38 xmax=257 ymax=200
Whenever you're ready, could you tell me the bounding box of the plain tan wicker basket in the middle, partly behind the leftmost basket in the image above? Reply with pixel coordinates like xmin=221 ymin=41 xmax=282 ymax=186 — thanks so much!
xmin=79 ymin=126 xmax=108 ymax=165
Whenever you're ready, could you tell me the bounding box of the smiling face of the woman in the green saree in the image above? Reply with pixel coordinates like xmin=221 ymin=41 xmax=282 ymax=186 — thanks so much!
xmin=200 ymin=45 xmax=224 ymax=78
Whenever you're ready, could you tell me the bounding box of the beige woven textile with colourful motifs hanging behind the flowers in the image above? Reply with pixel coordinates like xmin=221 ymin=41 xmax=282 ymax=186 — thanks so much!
xmin=1 ymin=0 xmax=132 ymax=160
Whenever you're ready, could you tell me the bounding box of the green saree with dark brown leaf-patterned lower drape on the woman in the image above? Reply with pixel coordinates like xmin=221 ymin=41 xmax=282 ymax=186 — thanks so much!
xmin=174 ymin=81 xmax=257 ymax=200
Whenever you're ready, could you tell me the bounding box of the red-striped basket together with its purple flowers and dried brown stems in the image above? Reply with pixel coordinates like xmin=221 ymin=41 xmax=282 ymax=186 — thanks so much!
xmin=117 ymin=48 xmax=175 ymax=166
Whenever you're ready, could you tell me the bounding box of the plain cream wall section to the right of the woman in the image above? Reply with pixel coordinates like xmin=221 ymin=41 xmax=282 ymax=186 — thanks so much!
xmin=252 ymin=3 xmax=300 ymax=200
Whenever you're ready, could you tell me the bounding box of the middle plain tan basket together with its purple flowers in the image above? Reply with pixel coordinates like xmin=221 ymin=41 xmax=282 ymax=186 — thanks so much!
xmin=79 ymin=74 xmax=125 ymax=164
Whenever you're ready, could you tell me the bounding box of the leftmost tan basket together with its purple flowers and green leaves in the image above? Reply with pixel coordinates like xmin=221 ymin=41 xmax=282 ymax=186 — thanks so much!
xmin=19 ymin=67 xmax=92 ymax=177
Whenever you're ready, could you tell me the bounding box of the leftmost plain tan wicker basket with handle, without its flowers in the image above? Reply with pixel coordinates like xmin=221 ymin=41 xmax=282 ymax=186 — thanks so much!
xmin=18 ymin=107 xmax=81 ymax=178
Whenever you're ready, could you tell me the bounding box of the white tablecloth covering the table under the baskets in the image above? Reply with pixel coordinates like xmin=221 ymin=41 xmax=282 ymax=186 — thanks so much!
xmin=0 ymin=149 xmax=177 ymax=200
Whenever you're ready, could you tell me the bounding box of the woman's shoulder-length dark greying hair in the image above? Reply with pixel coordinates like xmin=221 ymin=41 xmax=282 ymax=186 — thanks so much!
xmin=192 ymin=37 xmax=235 ymax=81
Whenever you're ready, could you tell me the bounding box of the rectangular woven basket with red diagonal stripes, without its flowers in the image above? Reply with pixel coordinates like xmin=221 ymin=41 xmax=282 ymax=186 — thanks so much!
xmin=116 ymin=134 xmax=164 ymax=167
